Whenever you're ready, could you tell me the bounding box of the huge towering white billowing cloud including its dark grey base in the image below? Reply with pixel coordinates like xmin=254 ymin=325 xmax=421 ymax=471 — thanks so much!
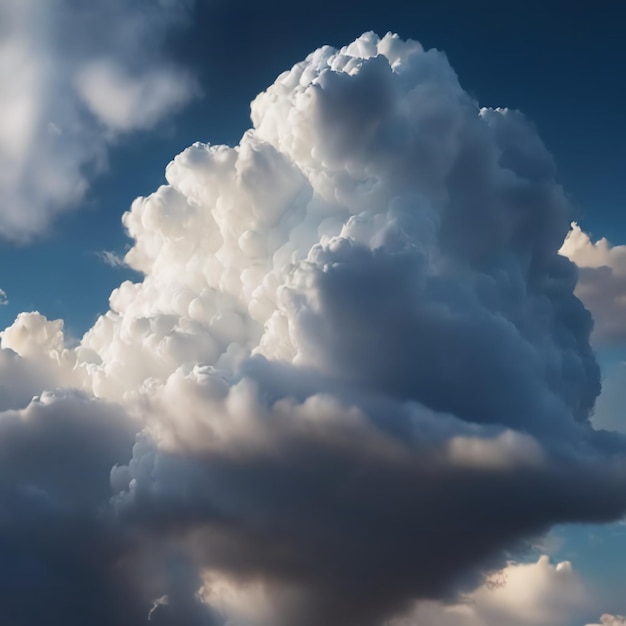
xmin=0 ymin=33 xmax=626 ymax=626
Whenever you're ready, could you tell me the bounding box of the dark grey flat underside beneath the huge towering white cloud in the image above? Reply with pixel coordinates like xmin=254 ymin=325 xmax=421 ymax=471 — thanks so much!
xmin=111 ymin=388 xmax=624 ymax=626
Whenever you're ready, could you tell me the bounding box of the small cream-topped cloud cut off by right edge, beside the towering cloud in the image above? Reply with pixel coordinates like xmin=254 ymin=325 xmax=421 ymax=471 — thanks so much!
xmin=560 ymin=223 xmax=626 ymax=345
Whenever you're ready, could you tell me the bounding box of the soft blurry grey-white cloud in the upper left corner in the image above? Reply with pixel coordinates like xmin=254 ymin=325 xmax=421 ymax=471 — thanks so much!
xmin=0 ymin=0 xmax=197 ymax=240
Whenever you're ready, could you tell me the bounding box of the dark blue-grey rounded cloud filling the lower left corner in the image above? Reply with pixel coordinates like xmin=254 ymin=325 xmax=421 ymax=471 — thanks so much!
xmin=0 ymin=391 xmax=215 ymax=626
